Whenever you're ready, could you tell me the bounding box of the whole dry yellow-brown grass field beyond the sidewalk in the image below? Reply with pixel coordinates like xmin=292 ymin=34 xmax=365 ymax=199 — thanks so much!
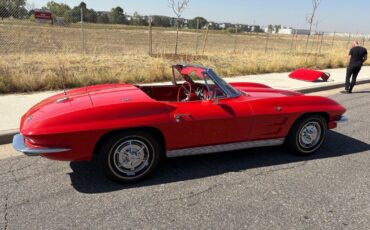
xmin=0 ymin=21 xmax=368 ymax=93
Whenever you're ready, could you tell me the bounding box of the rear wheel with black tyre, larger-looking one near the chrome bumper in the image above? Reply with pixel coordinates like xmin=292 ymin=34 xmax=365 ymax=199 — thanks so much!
xmin=99 ymin=131 xmax=161 ymax=183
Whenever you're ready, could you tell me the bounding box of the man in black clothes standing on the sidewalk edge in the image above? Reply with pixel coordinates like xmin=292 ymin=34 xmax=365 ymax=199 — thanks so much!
xmin=342 ymin=41 xmax=367 ymax=93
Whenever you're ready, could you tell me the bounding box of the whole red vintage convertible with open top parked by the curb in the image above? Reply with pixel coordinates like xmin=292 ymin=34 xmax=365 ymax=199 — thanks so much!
xmin=13 ymin=65 xmax=346 ymax=182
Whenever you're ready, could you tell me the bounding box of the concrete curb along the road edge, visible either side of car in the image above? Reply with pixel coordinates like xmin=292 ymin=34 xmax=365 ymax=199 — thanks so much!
xmin=0 ymin=78 xmax=370 ymax=145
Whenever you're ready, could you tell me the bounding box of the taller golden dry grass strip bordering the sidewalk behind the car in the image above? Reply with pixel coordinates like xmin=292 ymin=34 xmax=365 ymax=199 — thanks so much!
xmin=0 ymin=50 xmax=344 ymax=93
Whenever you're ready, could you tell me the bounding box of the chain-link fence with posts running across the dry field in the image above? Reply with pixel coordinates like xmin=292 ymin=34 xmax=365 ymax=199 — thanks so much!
xmin=0 ymin=7 xmax=370 ymax=55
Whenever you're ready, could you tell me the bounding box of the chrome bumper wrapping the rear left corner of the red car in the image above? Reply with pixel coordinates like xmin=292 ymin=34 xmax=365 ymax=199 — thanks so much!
xmin=13 ymin=134 xmax=70 ymax=156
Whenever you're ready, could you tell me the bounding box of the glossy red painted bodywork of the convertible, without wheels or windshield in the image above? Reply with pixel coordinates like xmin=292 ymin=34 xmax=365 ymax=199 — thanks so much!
xmin=20 ymin=73 xmax=345 ymax=161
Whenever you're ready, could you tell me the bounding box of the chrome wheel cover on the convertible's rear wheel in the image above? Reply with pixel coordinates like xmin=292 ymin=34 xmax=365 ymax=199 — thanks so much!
xmin=112 ymin=139 xmax=150 ymax=176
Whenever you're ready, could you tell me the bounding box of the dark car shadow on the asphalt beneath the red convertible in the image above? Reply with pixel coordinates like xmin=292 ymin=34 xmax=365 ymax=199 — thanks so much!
xmin=70 ymin=131 xmax=370 ymax=194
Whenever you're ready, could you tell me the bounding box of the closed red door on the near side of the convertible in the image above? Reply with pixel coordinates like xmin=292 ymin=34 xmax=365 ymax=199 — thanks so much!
xmin=167 ymin=98 xmax=252 ymax=149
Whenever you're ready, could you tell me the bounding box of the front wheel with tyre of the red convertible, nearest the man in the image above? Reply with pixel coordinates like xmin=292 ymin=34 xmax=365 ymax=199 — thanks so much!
xmin=286 ymin=115 xmax=327 ymax=155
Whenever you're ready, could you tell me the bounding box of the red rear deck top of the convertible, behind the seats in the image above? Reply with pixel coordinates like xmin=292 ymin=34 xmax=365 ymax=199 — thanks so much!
xmin=20 ymin=84 xmax=151 ymax=135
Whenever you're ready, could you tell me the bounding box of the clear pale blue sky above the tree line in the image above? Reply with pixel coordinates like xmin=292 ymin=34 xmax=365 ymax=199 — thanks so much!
xmin=27 ymin=0 xmax=370 ymax=34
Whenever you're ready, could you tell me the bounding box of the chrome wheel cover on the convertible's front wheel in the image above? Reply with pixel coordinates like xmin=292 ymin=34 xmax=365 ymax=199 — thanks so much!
xmin=298 ymin=121 xmax=322 ymax=149
